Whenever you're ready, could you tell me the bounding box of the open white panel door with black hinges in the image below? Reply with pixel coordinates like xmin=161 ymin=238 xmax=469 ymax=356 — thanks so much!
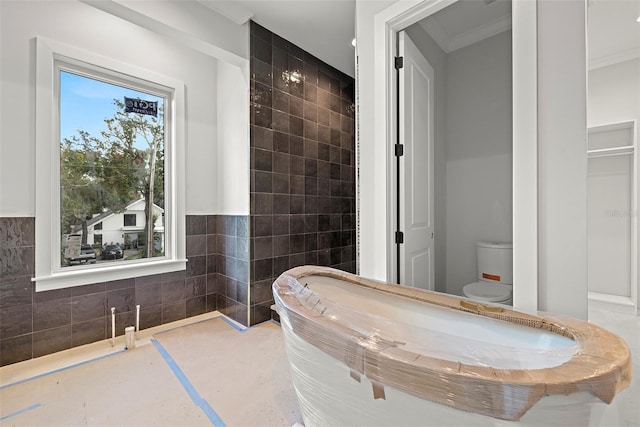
xmin=399 ymin=32 xmax=435 ymax=290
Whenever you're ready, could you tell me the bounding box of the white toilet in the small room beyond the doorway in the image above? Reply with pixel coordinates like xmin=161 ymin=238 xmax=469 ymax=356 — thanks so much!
xmin=462 ymin=242 xmax=513 ymax=305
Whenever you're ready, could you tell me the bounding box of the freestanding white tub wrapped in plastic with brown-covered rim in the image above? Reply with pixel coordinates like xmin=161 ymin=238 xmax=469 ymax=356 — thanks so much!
xmin=273 ymin=266 xmax=631 ymax=427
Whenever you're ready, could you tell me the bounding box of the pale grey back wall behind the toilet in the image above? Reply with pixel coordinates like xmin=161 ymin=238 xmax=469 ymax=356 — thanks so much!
xmin=446 ymin=31 xmax=513 ymax=295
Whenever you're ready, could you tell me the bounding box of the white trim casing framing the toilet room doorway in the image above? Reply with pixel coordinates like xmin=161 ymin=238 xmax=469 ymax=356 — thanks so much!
xmin=356 ymin=0 xmax=539 ymax=311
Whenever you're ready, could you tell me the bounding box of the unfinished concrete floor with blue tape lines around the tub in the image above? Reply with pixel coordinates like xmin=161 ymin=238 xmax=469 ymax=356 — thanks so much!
xmin=0 ymin=308 xmax=640 ymax=427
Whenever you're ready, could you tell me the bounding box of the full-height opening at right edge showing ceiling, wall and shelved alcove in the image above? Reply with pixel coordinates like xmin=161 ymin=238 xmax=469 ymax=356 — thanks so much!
xmin=587 ymin=1 xmax=640 ymax=315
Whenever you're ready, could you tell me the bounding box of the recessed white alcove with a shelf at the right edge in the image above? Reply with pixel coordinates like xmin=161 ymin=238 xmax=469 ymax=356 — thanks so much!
xmin=587 ymin=120 xmax=638 ymax=314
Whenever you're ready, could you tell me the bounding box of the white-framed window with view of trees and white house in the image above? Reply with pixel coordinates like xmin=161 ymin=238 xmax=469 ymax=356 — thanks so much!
xmin=34 ymin=38 xmax=186 ymax=290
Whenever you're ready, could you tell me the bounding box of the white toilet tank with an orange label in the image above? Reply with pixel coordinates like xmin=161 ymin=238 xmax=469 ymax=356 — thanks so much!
xmin=476 ymin=242 xmax=513 ymax=285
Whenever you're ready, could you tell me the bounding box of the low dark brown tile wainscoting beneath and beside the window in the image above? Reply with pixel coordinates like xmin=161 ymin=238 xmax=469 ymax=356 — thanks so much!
xmin=0 ymin=215 xmax=249 ymax=366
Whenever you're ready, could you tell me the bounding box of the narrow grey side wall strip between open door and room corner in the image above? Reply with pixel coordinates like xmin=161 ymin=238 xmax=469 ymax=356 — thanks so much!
xmin=407 ymin=24 xmax=447 ymax=292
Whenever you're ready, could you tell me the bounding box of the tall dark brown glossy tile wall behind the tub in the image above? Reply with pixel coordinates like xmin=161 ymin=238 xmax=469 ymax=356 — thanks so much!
xmin=249 ymin=22 xmax=355 ymax=325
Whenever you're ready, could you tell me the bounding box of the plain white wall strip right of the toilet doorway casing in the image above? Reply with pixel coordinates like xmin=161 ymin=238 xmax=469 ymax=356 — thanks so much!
xmin=536 ymin=0 xmax=587 ymax=319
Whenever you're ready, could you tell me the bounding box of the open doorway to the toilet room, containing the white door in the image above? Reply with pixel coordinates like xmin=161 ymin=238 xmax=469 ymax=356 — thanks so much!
xmin=391 ymin=0 xmax=514 ymax=295
